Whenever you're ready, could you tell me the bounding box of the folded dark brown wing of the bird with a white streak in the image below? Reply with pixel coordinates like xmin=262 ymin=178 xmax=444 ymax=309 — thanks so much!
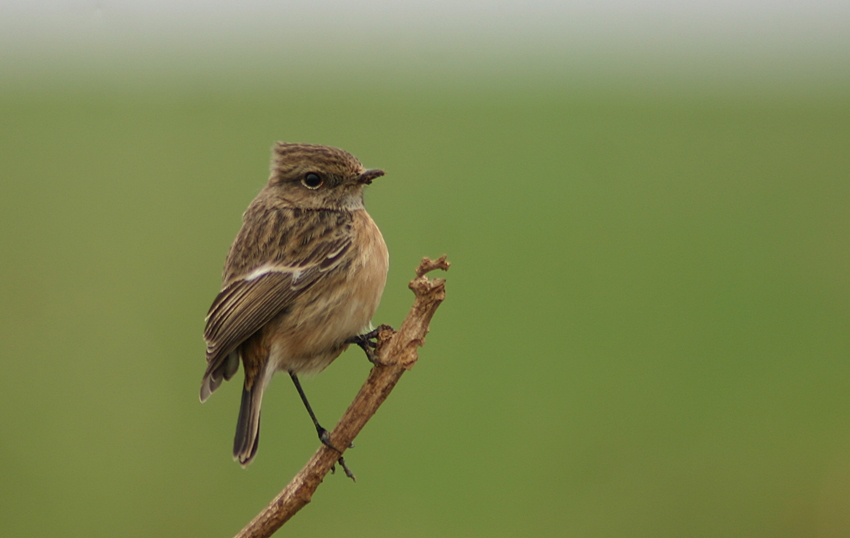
xmin=201 ymin=203 xmax=352 ymax=400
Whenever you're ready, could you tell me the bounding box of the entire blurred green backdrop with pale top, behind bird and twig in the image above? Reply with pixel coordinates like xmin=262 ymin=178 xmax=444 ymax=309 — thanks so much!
xmin=0 ymin=1 xmax=850 ymax=538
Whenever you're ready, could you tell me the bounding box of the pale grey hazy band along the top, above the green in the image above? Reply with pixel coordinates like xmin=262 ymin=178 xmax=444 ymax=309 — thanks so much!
xmin=0 ymin=0 xmax=850 ymax=82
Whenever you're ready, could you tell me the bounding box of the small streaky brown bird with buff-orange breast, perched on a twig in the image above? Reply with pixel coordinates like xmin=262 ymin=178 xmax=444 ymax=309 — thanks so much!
xmin=201 ymin=142 xmax=389 ymax=466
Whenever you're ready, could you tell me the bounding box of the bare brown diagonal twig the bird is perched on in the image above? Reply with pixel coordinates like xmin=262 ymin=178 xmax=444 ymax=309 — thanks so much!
xmin=229 ymin=256 xmax=450 ymax=538
